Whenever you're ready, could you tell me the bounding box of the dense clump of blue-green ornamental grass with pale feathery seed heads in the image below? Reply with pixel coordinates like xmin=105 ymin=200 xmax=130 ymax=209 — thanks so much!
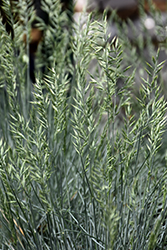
xmin=0 ymin=0 xmax=167 ymax=250
